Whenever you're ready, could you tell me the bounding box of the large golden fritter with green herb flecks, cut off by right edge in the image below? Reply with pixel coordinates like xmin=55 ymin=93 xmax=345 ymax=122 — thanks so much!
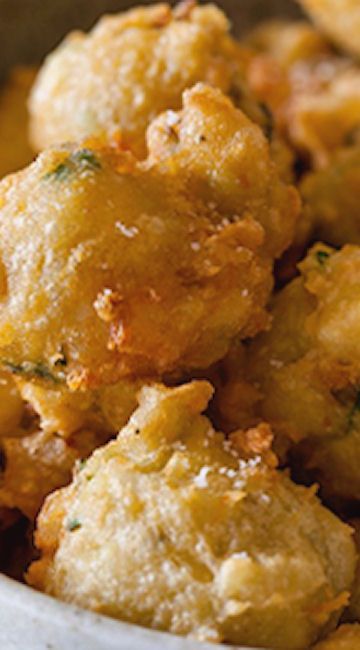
xmin=243 ymin=245 xmax=360 ymax=499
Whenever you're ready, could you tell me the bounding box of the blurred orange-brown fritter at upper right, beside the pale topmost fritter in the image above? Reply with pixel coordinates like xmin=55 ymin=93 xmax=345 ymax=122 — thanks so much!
xmin=248 ymin=23 xmax=360 ymax=168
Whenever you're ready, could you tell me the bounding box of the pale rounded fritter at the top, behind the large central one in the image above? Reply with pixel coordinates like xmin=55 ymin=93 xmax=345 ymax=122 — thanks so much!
xmin=30 ymin=2 xmax=264 ymax=157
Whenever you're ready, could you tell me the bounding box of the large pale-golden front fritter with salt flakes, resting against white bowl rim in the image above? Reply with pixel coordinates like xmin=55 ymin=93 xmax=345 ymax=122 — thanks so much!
xmin=28 ymin=382 xmax=355 ymax=650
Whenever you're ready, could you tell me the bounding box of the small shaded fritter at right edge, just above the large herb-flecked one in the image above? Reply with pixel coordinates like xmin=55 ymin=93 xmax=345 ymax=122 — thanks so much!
xmin=297 ymin=143 xmax=360 ymax=246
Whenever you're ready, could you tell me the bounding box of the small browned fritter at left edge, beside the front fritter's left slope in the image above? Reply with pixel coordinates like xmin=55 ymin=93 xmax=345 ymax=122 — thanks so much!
xmin=0 ymin=431 xmax=109 ymax=520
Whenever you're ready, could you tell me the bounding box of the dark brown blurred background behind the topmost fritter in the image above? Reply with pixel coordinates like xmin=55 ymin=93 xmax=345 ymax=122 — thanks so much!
xmin=0 ymin=0 xmax=299 ymax=76
